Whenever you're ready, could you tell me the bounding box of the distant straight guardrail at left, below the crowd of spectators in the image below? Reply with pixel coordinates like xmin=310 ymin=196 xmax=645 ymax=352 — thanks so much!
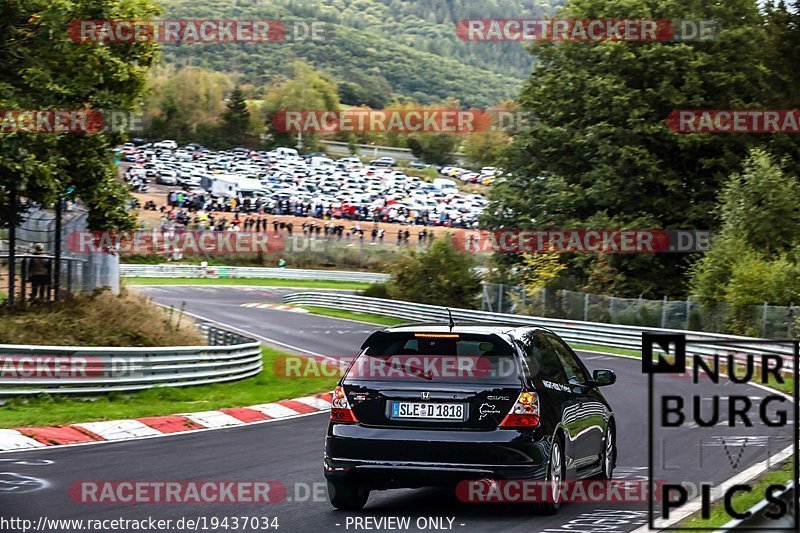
xmin=119 ymin=264 xmax=389 ymax=283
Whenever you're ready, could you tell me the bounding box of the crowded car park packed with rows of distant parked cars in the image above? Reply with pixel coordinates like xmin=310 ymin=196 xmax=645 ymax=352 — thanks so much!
xmin=118 ymin=140 xmax=493 ymax=228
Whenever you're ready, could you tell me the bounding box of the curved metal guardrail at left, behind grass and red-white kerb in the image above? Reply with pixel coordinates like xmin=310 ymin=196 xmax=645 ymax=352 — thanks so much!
xmin=0 ymin=324 xmax=263 ymax=397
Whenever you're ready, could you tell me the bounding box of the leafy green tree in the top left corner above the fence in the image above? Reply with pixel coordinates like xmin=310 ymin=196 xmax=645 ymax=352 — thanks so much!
xmin=0 ymin=0 xmax=157 ymax=229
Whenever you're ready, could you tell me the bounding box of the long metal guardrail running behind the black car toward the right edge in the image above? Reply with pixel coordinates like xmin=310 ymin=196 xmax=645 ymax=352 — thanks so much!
xmin=283 ymin=292 xmax=794 ymax=369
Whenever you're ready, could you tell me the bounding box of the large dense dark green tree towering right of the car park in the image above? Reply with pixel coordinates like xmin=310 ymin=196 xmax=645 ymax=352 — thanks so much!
xmin=485 ymin=0 xmax=800 ymax=296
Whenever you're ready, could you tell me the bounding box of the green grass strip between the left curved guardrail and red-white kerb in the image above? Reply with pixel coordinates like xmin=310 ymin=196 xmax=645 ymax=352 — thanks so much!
xmin=0 ymin=347 xmax=338 ymax=428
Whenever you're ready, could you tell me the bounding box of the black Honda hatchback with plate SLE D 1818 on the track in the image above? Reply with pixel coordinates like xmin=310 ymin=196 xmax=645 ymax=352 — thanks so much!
xmin=324 ymin=324 xmax=616 ymax=514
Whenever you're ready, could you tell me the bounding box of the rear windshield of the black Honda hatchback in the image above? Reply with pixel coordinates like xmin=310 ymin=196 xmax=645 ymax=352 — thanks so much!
xmin=347 ymin=333 xmax=519 ymax=384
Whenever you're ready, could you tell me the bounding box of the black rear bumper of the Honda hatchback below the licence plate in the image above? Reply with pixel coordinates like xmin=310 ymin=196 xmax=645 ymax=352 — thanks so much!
xmin=325 ymin=424 xmax=550 ymax=488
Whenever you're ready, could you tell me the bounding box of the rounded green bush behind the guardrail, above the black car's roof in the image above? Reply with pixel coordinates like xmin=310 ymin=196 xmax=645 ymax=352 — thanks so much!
xmin=388 ymin=236 xmax=481 ymax=309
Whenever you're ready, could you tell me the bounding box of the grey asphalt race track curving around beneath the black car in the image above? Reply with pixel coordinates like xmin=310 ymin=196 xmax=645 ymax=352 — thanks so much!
xmin=0 ymin=287 xmax=791 ymax=533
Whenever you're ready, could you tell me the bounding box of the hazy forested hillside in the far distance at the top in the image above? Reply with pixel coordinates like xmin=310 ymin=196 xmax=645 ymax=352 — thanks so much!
xmin=163 ymin=0 xmax=560 ymax=107
